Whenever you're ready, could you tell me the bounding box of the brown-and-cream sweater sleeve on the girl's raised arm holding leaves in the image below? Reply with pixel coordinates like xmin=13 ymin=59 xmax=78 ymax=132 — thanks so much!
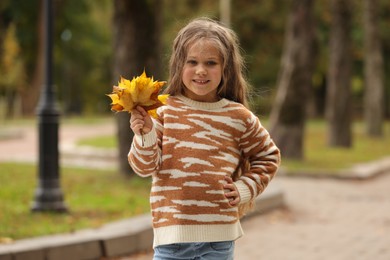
xmin=128 ymin=117 xmax=161 ymax=177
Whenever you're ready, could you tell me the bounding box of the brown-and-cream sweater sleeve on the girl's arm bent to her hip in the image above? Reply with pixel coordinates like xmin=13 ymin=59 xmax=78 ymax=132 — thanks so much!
xmin=235 ymin=114 xmax=281 ymax=203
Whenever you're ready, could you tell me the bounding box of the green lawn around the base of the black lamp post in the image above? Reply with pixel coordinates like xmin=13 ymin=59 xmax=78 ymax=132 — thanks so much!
xmin=0 ymin=163 xmax=151 ymax=241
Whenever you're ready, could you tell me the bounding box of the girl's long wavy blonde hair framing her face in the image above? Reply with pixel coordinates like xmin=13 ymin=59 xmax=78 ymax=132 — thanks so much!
xmin=165 ymin=17 xmax=249 ymax=107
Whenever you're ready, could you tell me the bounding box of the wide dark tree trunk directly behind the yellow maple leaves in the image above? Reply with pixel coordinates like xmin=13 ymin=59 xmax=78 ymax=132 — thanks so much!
xmin=113 ymin=0 xmax=162 ymax=177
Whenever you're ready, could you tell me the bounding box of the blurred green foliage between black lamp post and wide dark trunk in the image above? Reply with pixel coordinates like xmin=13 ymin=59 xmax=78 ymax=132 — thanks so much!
xmin=55 ymin=0 xmax=112 ymax=114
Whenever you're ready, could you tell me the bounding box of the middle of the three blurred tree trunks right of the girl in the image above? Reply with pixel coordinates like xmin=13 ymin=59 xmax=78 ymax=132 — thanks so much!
xmin=326 ymin=0 xmax=352 ymax=147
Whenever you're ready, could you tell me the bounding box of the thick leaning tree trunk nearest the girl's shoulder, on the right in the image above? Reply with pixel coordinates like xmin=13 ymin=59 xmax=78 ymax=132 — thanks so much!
xmin=270 ymin=0 xmax=315 ymax=159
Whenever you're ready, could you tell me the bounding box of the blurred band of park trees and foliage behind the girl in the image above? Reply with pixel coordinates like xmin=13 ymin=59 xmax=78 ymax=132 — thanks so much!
xmin=0 ymin=0 xmax=390 ymax=162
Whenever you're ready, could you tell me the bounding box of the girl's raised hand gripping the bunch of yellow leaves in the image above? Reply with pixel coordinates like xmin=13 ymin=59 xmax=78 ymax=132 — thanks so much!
xmin=130 ymin=106 xmax=153 ymax=135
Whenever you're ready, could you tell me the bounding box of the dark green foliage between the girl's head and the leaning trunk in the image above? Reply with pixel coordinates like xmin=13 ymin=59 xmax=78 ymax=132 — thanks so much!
xmin=232 ymin=0 xmax=289 ymax=89
